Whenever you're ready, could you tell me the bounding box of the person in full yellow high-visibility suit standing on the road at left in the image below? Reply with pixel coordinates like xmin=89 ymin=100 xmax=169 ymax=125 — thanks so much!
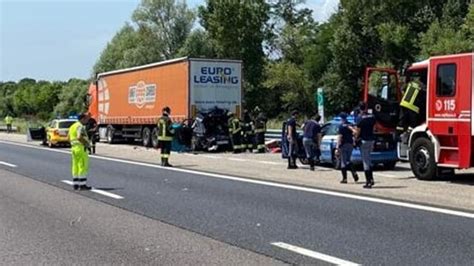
xmin=69 ymin=114 xmax=91 ymax=190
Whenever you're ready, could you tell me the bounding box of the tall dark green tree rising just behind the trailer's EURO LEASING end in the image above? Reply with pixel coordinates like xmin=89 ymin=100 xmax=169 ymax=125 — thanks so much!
xmin=199 ymin=0 xmax=270 ymax=107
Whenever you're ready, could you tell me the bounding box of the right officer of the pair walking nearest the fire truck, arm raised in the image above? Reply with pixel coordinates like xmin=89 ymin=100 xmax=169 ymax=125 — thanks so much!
xmin=356 ymin=105 xmax=375 ymax=188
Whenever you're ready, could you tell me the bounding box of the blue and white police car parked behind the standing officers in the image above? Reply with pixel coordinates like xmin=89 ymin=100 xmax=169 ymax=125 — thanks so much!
xmin=320 ymin=116 xmax=398 ymax=170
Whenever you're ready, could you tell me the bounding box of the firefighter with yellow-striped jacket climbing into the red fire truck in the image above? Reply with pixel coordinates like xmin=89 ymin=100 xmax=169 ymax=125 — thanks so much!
xmin=397 ymin=81 xmax=425 ymax=135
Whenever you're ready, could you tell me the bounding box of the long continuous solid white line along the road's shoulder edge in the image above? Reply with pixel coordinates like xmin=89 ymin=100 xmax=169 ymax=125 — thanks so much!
xmin=0 ymin=140 xmax=474 ymax=219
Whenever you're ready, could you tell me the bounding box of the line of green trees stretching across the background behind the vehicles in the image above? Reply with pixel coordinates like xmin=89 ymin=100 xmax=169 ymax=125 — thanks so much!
xmin=0 ymin=0 xmax=474 ymax=120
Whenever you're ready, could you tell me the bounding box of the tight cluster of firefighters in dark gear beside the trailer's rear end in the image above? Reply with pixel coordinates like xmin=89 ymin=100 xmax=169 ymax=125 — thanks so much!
xmin=228 ymin=107 xmax=267 ymax=153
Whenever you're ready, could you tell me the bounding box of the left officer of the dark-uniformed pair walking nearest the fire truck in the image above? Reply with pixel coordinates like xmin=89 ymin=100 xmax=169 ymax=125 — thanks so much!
xmin=336 ymin=113 xmax=359 ymax=184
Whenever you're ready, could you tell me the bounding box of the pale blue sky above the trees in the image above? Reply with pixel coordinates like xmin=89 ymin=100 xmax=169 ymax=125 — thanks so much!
xmin=0 ymin=0 xmax=339 ymax=81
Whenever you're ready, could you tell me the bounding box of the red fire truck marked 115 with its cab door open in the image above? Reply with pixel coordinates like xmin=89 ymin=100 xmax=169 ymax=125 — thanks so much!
xmin=364 ymin=53 xmax=474 ymax=180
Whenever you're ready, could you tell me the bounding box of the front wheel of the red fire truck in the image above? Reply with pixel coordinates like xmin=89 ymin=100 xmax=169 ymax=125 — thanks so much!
xmin=410 ymin=138 xmax=437 ymax=180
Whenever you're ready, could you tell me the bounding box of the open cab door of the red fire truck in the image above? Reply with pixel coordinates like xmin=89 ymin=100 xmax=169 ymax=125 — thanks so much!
xmin=364 ymin=68 xmax=402 ymax=133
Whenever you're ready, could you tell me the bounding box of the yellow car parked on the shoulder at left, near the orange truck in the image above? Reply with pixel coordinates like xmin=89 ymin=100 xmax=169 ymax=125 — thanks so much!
xmin=43 ymin=119 xmax=77 ymax=148
